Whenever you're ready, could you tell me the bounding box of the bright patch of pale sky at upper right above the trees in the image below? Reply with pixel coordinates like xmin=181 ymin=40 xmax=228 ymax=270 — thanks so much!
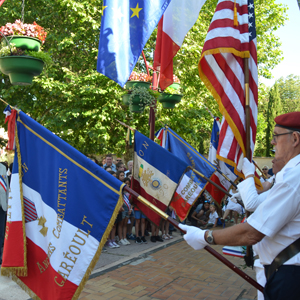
xmin=260 ymin=0 xmax=300 ymax=86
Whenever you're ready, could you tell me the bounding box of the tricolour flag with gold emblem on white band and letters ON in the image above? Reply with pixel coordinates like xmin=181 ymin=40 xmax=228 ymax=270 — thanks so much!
xmin=132 ymin=131 xmax=189 ymax=226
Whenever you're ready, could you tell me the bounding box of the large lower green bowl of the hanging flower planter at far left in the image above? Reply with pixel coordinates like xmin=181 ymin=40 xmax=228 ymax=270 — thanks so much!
xmin=0 ymin=56 xmax=44 ymax=85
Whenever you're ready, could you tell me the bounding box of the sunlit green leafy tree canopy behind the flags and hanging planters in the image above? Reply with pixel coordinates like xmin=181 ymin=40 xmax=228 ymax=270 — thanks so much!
xmin=0 ymin=0 xmax=286 ymax=155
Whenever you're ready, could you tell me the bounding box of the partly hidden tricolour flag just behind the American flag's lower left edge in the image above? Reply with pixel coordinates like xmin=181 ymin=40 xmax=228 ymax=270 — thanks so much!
xmin=206 ymin=118 xmax=237 ymax=204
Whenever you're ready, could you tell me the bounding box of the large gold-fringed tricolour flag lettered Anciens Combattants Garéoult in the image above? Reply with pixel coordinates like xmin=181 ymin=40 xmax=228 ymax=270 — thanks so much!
xmin=1 ymin=111 xmax=123 ymax=300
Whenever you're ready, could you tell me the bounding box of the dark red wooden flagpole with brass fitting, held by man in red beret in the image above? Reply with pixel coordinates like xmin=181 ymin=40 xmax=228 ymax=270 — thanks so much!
xmin=124 ymin=185 xmax=264 ymax=293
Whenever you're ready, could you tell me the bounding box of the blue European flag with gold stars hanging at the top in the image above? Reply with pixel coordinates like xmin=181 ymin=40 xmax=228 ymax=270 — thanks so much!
xmin=97 ymin=0 xmax=171 ymax=87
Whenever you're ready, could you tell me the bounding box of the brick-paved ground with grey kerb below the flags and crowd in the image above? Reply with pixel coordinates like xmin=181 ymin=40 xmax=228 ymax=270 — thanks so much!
xmin=0 ymin=226 xmax=256 ymax=300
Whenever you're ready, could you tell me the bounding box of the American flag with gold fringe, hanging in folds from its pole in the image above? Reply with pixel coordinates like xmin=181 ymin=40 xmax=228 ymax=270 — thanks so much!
xmin=198 ymin=0 xmax=258 ymax=175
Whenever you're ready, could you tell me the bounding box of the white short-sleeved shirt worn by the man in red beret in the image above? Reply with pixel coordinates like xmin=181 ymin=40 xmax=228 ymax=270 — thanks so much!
xmin=247 ymin=155 xmax=300 ymax=265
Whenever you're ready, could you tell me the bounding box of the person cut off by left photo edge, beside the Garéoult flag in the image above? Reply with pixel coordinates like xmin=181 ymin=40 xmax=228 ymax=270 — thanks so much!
xmin=0 ymin=162 xmax=9 ymax=265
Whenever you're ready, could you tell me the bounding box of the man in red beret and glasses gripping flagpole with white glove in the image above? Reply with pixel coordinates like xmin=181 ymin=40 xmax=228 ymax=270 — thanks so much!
xmin=179 ymin=112 xmax=300 ymax=300
